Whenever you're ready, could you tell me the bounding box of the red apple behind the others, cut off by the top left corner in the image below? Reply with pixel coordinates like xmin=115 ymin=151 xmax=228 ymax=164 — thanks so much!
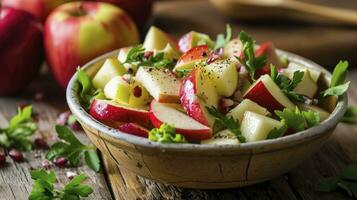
xmin=2 ymin=0 xmax=73 ymax=22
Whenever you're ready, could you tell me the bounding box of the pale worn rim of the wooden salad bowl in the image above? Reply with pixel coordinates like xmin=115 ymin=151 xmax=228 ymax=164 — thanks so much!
xmin=66 ymin=49 xmax=347 ymax=152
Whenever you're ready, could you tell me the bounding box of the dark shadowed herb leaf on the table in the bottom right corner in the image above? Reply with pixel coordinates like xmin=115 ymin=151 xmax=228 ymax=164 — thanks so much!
xmin=319 ymin=163 xmax=357 ymax=199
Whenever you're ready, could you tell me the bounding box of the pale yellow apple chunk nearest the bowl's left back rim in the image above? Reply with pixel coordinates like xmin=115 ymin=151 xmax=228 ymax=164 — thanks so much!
xmin=92 ymin=58 xmax=126 ymax=89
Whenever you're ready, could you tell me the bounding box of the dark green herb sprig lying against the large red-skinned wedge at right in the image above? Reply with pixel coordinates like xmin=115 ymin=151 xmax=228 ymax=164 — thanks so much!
xmin=270 ymin=64 xmax=305 ymax=102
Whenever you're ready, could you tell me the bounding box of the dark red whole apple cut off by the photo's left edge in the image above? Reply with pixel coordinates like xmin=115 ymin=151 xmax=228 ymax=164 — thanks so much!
xmin=0 ymin=7 xmax=43 ymax=95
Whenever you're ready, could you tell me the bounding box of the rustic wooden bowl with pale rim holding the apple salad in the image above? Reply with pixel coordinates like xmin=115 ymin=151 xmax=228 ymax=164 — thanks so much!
xmin=67 ymin=50 xmax=347 ymax=189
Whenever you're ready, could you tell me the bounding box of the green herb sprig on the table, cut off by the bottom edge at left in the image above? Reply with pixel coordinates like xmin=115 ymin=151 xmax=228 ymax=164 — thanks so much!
xmin=29 ymin=170 xmax=93 ymax=200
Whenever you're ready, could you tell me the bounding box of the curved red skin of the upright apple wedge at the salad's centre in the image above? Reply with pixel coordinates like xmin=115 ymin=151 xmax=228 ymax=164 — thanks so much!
xmin=179 ymin=69 xmax=209 ymax=126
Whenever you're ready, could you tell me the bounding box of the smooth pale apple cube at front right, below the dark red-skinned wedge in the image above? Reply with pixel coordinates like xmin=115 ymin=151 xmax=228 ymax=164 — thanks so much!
xmin=241 ymin=111 xmax=283 ymax=142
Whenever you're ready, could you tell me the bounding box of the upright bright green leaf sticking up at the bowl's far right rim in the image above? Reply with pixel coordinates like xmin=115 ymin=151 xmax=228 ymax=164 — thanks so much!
xmin=322 ymin=61 xmax=350 ymax=97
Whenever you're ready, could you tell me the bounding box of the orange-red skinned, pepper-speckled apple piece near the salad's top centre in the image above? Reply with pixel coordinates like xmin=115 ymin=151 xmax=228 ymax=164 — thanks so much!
xmin=174 ymin=45 xmax=210 ymax=71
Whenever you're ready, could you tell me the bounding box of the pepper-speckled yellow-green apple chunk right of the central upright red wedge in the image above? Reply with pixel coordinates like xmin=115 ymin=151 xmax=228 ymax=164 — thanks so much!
xmin=204 ymin=59 xmax=238 ymax=97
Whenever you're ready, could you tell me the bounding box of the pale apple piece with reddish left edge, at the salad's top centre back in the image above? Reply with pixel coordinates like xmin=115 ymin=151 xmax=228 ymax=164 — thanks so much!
xmin=178 ymin=31 xmax=215 ymax=53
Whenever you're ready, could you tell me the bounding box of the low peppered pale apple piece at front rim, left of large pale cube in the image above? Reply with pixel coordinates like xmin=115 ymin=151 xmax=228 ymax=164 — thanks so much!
xmin=201 ymin=129 xmax=240 ymax=145
